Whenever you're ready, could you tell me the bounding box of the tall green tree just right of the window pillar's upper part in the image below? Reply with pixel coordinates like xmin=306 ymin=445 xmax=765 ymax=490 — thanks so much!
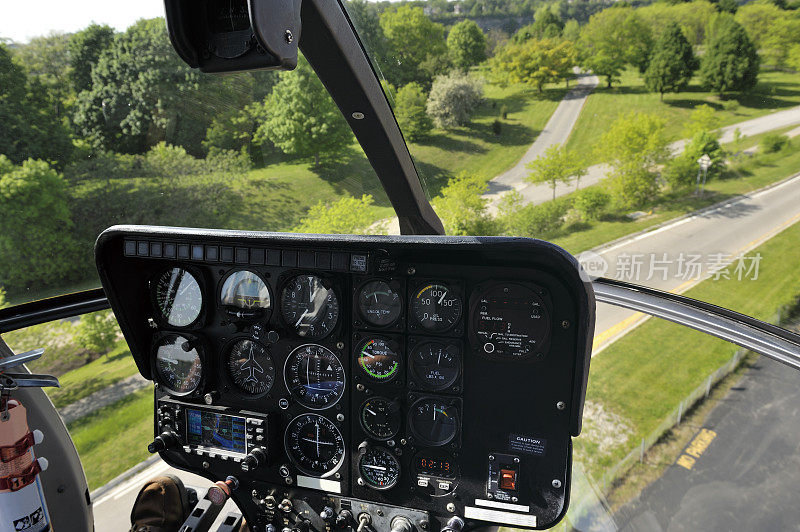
xmin=380 ymin=4 xmax=447 ymax=86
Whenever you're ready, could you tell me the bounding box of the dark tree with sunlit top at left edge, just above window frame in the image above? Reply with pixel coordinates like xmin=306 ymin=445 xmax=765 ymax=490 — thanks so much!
xmin=0 ymin=155 xmax=76 ymax=292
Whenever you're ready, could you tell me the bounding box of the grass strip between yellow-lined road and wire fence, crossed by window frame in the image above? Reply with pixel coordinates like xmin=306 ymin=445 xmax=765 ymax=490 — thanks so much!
xmin=576 ymin=220 xmax=800 ymax=479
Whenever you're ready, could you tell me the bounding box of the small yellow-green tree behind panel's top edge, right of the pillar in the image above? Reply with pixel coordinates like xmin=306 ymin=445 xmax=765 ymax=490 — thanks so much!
xmin=433 ymin=172 xmax=496 ymax=235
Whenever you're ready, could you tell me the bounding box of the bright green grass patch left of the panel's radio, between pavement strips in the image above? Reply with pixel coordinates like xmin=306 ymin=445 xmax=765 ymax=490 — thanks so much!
xmin=67 ymin=388 xmax=153 ymax=490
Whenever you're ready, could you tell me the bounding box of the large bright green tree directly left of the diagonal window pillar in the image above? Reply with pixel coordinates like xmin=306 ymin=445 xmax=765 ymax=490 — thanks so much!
xmin=254 ymin=59 xmax=353 ymax=167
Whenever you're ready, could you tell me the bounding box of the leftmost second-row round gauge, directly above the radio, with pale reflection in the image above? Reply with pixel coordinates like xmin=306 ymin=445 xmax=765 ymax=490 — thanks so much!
xmin=155 ymin=334 xmax=203 ymax=395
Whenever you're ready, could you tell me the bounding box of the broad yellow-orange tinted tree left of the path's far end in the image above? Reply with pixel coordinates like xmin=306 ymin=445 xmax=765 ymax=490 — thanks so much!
xmin=491 ymin=39 xmax=576 ymax=92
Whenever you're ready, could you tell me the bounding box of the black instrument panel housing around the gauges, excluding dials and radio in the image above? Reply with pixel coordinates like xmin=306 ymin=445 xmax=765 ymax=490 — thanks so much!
xmin=95 ymin=226 xmax=595 ymax=528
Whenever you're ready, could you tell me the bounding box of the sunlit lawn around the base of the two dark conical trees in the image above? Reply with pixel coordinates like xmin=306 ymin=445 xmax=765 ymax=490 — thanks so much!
xmin=567 ymin=69 xmax=800 ymax=161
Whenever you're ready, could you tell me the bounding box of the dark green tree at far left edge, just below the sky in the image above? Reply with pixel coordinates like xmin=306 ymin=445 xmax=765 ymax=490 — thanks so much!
xmin=0 ymin=44 xmax=72 ymax=165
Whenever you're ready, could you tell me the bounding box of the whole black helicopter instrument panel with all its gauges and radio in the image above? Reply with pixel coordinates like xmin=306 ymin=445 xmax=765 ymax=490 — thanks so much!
xmin=96 ymin=226 xmax=594 ymax=531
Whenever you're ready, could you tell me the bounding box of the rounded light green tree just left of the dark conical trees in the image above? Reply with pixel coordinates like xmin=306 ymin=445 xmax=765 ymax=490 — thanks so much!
xmin=578 ymin=7 xmax=652 ymax=88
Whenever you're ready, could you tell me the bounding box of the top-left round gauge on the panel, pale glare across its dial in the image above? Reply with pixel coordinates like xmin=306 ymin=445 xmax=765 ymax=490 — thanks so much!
xmin=155 ymin=268 xmax=203 ymax=327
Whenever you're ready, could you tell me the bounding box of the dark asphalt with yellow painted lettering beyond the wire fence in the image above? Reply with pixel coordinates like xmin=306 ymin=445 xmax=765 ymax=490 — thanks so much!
xmin=615 ymin=357 xmax=800 ymax=532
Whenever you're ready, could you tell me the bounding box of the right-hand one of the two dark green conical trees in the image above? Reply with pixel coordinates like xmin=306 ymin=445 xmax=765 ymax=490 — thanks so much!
xmin=700 ymin=16 xmax=760 ymax=95
